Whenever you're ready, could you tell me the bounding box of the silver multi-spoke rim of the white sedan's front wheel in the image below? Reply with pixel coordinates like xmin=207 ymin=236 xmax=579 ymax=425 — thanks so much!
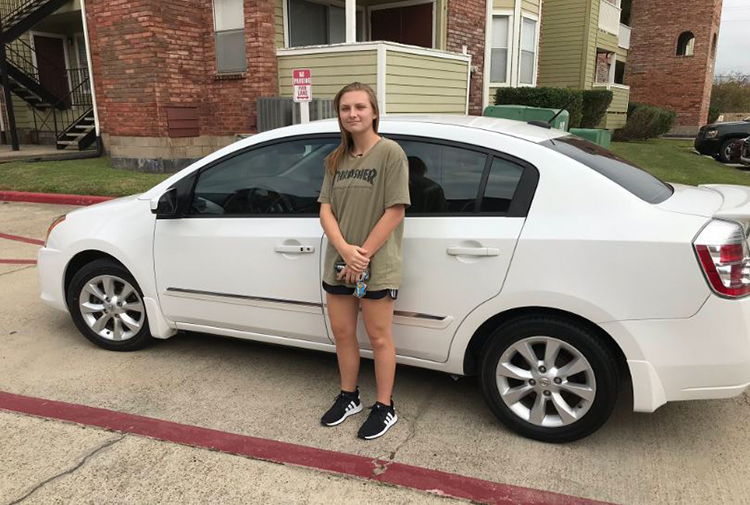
xmin=78 ymin=275 xmax=146 ymax=341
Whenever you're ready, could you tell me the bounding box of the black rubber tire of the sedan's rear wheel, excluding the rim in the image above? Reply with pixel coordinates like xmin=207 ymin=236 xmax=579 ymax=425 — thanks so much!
xmin=481 ymin=316 xmax=620 ymax=443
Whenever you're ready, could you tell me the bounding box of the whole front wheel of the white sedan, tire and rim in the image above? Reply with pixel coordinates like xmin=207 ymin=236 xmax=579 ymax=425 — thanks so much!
xmin=67 ymin=259 xmax=153 ymax=351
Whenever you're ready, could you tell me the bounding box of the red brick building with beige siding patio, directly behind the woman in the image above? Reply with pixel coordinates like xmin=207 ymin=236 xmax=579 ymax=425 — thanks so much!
xmin=0 ymin=0 xmax=541 ymax=172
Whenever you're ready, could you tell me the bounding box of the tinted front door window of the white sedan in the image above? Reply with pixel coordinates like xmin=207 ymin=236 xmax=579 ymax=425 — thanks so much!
xmin=189 ymin=138 xmax=340 ymax=217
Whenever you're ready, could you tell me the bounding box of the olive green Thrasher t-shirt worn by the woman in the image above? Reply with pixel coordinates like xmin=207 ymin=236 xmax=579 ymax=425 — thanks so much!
xmin=318 ymin=138 xmax=411 ymax=291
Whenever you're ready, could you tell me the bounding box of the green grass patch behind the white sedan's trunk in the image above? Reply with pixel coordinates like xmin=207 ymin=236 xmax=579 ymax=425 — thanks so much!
xmin=612 ymin=139 xmax=750 ymax=186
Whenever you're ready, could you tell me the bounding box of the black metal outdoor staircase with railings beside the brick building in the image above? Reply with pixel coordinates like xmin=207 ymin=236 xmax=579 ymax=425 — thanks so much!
xmin=0 ymin=0 xmax=96 ymax=150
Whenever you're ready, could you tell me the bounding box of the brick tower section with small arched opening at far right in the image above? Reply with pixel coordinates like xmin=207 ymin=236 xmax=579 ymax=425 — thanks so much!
xmin=625 ymin=0 xmax=722 ymax=135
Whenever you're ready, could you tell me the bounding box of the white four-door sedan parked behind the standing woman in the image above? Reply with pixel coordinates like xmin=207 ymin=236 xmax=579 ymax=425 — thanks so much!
xmin=39 ymin=116 xmax=750 ymax=442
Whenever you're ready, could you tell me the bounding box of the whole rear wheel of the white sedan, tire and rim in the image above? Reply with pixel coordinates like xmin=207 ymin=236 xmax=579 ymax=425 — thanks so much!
xmin=481 ymin=316 xmax=619 ymax=443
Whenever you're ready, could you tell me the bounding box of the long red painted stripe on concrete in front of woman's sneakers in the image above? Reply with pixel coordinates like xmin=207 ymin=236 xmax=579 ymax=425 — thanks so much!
xmin=0 ymin=391 xmax=602 ymax=505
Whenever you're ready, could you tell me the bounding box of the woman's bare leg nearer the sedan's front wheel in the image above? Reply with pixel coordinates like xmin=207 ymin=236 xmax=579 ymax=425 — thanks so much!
xmin=326 ymin=293 xmax=359 ymax=391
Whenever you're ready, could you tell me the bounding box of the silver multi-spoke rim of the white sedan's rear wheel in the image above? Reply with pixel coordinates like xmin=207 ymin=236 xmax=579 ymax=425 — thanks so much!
xmin=495 ymin=337 xmax=596 ymax=428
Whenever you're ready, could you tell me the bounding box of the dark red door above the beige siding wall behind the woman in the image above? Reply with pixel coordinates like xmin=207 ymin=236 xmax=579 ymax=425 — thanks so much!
xmin=370 ymin=2 xmax=434 ymax=48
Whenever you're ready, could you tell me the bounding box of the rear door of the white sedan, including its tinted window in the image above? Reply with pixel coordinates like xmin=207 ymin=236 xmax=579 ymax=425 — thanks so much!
xmin=326 ymin=136 xmax=538 ymax=362
